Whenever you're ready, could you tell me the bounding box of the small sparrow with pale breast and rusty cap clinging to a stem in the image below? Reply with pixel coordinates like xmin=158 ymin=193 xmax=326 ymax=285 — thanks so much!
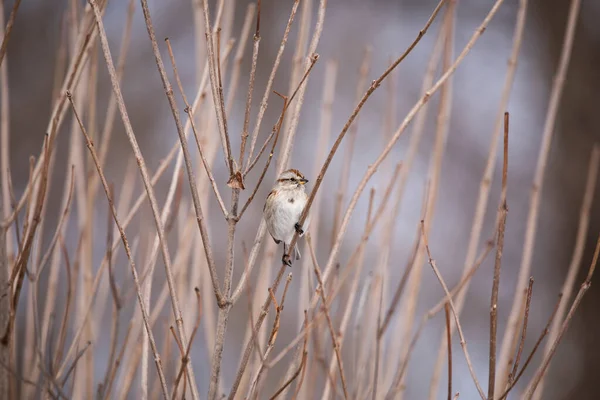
xmin=263 ymin=169 xmax=308 ymax=266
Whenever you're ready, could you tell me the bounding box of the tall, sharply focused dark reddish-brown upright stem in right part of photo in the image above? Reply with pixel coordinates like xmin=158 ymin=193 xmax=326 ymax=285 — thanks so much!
xmin=486 ymin=112 xmax=509 ymax=400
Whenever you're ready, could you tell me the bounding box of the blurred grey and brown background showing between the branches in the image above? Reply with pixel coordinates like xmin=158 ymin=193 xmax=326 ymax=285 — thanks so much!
xmin=3 ymin=0 xmax=600 ymax=400
